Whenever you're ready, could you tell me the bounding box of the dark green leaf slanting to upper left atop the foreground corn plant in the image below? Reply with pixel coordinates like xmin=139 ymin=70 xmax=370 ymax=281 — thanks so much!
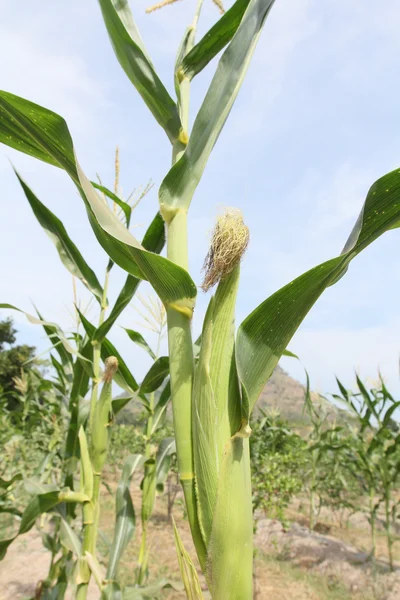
xmin=99 ymin=0 xmax=181 ymax=143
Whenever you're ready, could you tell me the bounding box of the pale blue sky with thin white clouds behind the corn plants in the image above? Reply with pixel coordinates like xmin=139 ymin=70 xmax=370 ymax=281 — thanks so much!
xmin=0 ymin=0 xmax=400 ymax=404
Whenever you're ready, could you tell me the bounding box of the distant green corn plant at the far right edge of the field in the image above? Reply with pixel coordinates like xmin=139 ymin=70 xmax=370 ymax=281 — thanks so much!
xmin=334 ymin=375 xmax=400 ymax=570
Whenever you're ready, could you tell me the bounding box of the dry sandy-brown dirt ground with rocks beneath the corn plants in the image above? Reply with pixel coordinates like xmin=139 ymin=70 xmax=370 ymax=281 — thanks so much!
xmin=0 ymin=478 xmax=400 ymax=600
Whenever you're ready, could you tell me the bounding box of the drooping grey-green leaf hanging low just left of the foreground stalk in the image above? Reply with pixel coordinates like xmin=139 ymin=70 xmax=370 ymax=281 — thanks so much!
xmin=106 ymin=454 xmax=145 ymax=580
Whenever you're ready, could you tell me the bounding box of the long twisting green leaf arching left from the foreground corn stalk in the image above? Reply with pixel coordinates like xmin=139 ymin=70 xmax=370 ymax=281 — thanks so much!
xmin=0 ymin=92 xmax=197 ymax=318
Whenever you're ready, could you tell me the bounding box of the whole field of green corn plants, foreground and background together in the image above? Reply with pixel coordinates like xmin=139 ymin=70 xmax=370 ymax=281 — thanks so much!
xmin=0 ymin=0 xmax=400 ymax=600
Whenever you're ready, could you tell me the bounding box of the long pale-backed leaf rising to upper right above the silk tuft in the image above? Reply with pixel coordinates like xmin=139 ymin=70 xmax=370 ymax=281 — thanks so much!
xmin=159 ymin=0 xmax=273 ymax=220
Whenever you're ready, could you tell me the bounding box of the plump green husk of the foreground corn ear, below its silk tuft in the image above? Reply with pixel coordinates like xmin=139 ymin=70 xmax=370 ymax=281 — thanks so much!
xmin=193 ymin=264 xmax=253 ymax=600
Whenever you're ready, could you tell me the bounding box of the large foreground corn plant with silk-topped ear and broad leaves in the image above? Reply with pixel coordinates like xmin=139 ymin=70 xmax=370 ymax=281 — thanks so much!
xmin=0 ymin=0 xmax=400 ymax=600
